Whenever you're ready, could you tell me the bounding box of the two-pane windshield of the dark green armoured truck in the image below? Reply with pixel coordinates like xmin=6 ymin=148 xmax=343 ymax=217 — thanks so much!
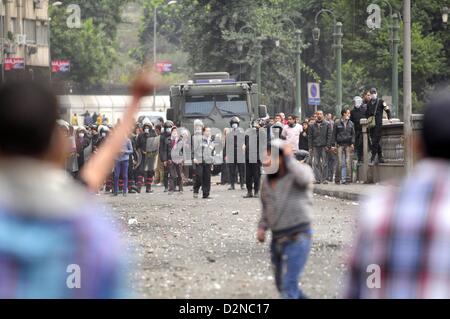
xmin=184 ymin=94 xmax=248 ymax=116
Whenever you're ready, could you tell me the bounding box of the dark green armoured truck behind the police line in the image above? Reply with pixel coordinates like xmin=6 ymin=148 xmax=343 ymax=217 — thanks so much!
xmin=167 ymin=72 xmax=268 ymax=173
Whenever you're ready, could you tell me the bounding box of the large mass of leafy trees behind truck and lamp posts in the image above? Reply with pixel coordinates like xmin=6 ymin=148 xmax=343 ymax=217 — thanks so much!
xmin=133 ymin=0 xmax=450 ymax=117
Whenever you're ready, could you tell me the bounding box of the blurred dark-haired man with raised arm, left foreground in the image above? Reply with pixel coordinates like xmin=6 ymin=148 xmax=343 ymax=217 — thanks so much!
xmin=0 ymin=71 xmax=160 ymax=298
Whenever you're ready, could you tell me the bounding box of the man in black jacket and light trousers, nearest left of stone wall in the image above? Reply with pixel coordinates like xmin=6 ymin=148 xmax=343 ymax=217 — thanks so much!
xmin=332 ymin=109 xmax=355 ymax=185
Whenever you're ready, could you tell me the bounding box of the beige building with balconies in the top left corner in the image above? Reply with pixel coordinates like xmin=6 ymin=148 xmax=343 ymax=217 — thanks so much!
xmin=0 ymin=0 xmax=51 ymax=81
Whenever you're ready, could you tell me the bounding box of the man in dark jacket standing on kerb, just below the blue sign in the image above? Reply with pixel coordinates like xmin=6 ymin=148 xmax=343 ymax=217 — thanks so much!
xmin=308 ymin=111 xmax=333 ymax=184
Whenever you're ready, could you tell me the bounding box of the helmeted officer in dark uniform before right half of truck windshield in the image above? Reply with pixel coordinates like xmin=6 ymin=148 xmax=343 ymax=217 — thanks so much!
xmin=225 ymin=116 xmax=245 ymax=190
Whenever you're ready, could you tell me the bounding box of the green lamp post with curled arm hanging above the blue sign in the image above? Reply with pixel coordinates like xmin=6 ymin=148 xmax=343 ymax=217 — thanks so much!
xmin=313 ymin=9 xmax=344 ymax=115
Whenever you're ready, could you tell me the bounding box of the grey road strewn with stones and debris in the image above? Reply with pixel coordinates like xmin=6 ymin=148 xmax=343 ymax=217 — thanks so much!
xmin=99 ymin=182 xmax=359 ymax=299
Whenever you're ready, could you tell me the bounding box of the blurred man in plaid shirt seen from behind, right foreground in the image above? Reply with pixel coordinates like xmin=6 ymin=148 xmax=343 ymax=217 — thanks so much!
xmin=346 ymin=92 xmax=450 ymax=299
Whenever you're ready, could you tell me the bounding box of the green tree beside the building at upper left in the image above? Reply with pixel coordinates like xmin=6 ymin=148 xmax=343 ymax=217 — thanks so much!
xmin=50 ymin=0 xmax=128 ymax=90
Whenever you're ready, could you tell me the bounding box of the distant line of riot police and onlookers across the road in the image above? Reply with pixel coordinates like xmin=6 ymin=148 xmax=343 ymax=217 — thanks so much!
xmin=59 ymin=88 xmax=390 ymax=198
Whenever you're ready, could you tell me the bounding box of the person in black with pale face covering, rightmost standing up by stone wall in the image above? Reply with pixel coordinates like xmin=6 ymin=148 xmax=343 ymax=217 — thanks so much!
xmin=366 ymin=88 xmax=391 ymax=164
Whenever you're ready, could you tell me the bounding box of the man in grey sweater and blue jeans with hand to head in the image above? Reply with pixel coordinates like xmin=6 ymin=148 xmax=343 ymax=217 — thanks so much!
xmin=257 ymin=140 xmax=313 ymax=299
